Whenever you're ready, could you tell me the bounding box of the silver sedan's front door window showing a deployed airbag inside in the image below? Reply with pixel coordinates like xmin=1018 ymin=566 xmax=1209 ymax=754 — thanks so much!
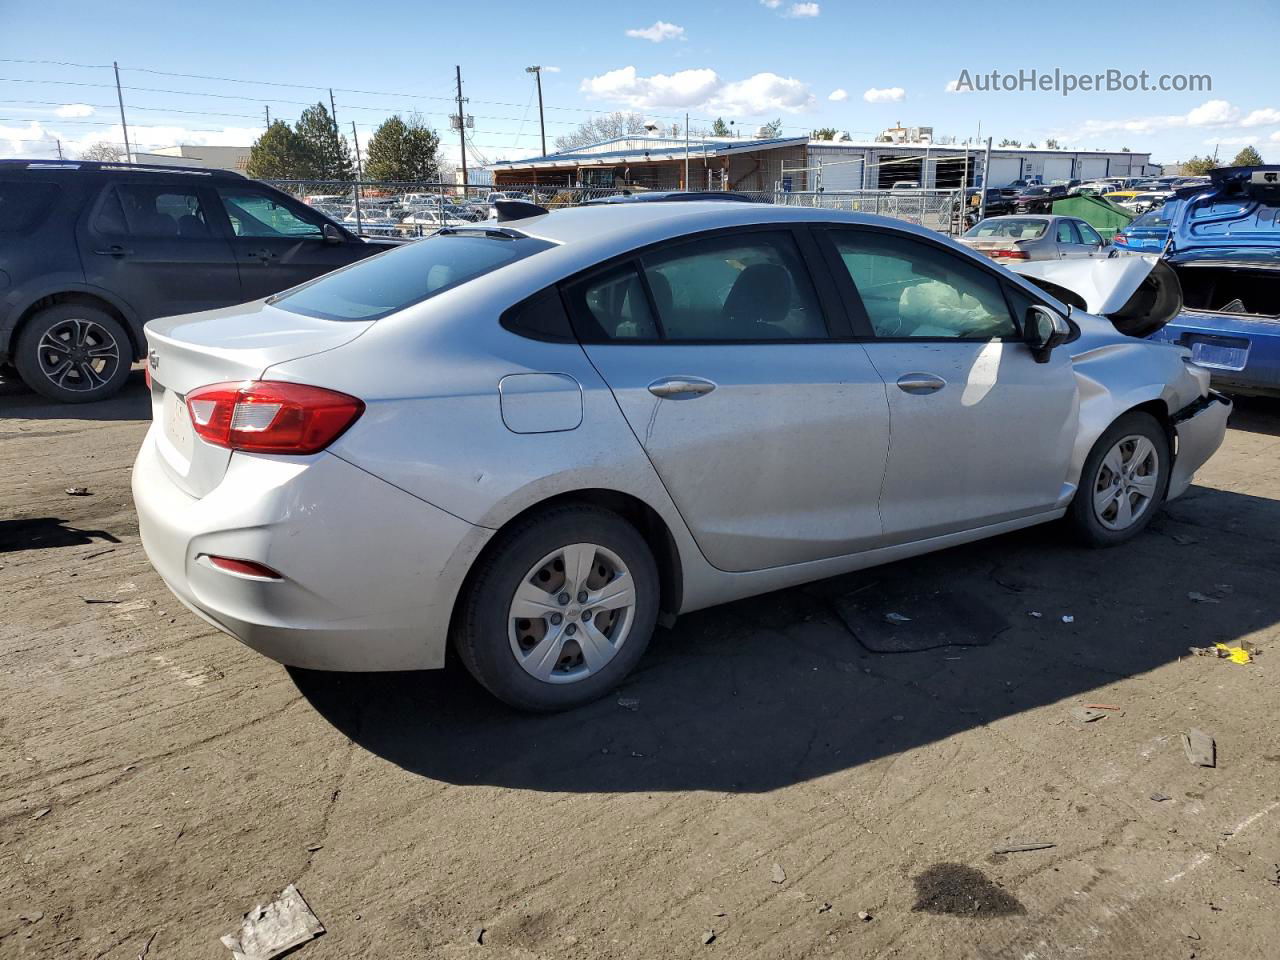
xmin=832 ymin=230 xmax=1018 ymax=340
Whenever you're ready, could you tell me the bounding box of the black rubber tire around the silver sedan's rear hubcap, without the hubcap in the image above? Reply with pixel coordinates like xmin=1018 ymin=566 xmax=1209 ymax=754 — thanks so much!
xmin=453 ymin=504 xmax=659 ymax=712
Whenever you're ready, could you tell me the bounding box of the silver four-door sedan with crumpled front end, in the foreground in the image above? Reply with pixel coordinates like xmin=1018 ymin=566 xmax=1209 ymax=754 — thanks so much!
xmin=133 ymin=202 xmax=1230 ymax=710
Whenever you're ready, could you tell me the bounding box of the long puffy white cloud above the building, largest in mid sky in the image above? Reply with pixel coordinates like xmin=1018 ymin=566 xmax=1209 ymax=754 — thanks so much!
xmin=580 ymin=67 xmax=814 ymax=115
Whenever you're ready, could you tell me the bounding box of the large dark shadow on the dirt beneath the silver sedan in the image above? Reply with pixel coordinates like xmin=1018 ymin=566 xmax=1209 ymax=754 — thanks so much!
xmin=291 ymin=488 xmax=1280 ymax=792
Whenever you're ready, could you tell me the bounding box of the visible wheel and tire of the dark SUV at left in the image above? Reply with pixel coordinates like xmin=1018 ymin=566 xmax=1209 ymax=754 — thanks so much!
xmin=13 ymin=303 xmax=133 ymax=403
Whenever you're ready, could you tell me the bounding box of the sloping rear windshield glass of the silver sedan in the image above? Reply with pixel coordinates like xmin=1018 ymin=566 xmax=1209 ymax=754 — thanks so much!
xmin=270 ymin=233 xmax=553 ymax=320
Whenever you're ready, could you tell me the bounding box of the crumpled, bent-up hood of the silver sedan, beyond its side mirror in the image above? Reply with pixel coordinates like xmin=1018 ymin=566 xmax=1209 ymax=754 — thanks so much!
xmin=1009 ymin=255 xmax=1183 ymax=337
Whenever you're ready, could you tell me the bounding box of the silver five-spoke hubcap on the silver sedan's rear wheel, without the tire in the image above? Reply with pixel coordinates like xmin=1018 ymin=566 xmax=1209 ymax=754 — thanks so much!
xmin=507 ymin=543 xmax=636 ymax=684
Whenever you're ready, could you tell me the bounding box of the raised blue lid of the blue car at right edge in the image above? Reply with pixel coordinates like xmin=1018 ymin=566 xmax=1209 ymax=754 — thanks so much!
xmin=1169 ymin=165 xmax=1280 ymax=266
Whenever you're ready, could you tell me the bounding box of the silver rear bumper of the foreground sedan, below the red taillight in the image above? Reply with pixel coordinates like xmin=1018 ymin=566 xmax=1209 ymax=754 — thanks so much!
xmin=133 ymin=428 xmax=492 ymax=671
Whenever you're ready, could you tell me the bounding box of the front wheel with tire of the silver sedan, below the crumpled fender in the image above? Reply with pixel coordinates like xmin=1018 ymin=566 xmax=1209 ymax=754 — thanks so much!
xmin=1066 ymin=412 xmax=1171 ymax=547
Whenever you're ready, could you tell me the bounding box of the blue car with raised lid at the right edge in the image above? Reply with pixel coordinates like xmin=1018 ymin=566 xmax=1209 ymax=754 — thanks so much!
xmin=1152 ymin=165 xmax=1280 ymax=397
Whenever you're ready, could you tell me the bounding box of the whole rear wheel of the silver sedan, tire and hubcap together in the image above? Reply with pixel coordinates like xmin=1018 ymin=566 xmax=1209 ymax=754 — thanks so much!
xmin=454 ymin=504 xmax=659 ymax=710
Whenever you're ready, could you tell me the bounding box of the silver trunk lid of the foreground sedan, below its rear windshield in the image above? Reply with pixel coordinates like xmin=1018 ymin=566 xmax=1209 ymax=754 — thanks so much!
xmin=146 ymin=301 xmax=375 ymax=497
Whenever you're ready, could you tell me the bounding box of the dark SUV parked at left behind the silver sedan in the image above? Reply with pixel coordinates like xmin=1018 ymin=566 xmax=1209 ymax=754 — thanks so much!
xmin=0 ymin=160 xmax=393 ymax=402
